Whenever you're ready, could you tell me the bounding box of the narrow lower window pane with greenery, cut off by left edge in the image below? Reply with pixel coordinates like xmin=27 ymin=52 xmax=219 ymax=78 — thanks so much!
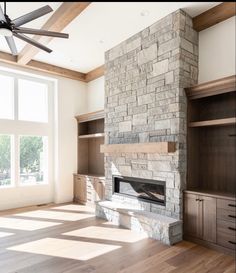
xmin=0 ymin=135 xmax=12 ymax=186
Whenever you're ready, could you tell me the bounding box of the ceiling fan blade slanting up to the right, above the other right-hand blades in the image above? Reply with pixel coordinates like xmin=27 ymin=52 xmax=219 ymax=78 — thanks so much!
xmin=12 ymin=5 xmax=53 ymax=27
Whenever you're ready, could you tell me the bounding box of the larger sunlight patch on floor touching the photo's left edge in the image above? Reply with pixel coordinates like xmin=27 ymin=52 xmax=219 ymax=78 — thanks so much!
xmin=0 ymin=217 xmax=61 ymax=231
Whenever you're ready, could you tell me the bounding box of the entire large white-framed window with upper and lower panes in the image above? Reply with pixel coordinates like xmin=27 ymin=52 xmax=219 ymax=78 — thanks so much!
xmin=0 ymin=70 xmax=54 ymax=188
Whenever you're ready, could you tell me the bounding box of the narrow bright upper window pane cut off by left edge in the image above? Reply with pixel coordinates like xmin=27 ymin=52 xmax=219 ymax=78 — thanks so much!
xmin=0 ymin=75 xmax=14 ymax=119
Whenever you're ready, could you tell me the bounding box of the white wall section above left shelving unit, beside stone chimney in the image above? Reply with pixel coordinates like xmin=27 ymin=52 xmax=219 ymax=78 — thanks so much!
xmin=87 ymin=76 xmax=105 ymax=112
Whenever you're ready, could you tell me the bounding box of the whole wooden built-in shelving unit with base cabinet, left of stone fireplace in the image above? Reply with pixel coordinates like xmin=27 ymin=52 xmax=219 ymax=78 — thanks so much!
xmin=74 ymin=111 xmax=105 ymax=205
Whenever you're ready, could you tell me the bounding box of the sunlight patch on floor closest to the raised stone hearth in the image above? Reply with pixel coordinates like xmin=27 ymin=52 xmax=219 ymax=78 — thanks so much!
xmin=62 ymin=226 xmax=147 ymax=243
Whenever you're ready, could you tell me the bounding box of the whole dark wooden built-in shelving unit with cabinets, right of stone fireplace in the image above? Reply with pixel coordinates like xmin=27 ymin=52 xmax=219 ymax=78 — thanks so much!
xmin=184 ymin=76 xmax=236 ymax=254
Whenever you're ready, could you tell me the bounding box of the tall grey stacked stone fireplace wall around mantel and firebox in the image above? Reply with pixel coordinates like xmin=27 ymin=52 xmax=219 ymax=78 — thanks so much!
xmin=105 ymin=10 xmax=198 ymax=219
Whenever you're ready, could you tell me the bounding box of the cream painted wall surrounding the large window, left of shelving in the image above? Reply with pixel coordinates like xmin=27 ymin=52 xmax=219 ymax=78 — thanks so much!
xmin=0 ymin=63 xmax=87 ymax=210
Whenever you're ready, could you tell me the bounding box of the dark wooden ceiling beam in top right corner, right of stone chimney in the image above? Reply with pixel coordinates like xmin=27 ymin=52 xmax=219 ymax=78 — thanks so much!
xmin=193 ymin=2 xmax=236 ymax=31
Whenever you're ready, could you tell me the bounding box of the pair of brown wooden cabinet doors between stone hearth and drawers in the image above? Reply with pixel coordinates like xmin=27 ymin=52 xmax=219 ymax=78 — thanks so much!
xmin=184 ymin=193 xmax=216 ymax=243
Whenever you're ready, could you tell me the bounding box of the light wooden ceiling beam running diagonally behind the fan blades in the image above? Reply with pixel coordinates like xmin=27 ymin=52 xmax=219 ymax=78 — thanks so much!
xmin=17 ymin=2 xmax=91 ymax=64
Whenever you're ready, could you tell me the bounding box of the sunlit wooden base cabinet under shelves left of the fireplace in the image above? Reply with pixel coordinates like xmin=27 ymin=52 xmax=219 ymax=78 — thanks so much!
xmin=74 ymin=174 xmax=105 ymax=205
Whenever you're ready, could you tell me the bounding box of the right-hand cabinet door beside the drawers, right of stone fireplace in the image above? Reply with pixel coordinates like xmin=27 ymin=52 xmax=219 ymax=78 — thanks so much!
xmin=200 ymin=196 xmax=216 ymax=243
